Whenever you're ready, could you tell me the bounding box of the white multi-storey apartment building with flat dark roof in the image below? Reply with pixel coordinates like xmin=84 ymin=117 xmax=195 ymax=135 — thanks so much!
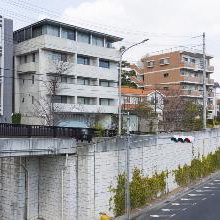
xmin=14 ymin=19 xmax=122 ymax=128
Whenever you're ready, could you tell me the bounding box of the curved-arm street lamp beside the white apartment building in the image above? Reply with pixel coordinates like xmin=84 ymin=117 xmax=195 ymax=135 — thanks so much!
xmin=118 ymin=39 xmax=149 ymax=136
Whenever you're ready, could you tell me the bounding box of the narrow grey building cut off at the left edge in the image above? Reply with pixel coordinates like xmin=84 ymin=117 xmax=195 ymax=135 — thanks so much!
xmin=0 ymin=16 xmax=13 ymax=123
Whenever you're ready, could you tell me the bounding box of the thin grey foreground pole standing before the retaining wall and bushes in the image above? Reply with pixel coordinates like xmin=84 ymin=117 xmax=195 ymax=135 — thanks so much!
xmin=125 ymin=112 xmax=131 ymax=220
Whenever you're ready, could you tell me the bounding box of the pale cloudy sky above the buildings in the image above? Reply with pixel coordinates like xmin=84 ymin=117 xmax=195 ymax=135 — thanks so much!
xmin=0 ymin=0 xmax=220 ymax=82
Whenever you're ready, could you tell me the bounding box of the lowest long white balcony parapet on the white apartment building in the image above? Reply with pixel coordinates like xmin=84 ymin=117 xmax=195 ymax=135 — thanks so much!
xmin=55 ymin=103 xmax=118 ymax=114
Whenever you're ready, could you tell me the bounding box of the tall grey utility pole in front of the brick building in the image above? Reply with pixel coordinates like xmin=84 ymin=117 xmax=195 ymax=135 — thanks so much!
xmin=202 ymin=32 xmax=207 ymax=129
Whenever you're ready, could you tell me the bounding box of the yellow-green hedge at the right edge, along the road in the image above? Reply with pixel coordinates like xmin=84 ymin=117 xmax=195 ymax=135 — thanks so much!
xmin=173 ymin=148 xmax=220 ymax=186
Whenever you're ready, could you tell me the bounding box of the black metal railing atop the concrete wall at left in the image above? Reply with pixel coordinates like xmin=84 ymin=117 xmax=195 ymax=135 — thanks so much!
xmin=0 ymin=123 xmax=117 ymax=142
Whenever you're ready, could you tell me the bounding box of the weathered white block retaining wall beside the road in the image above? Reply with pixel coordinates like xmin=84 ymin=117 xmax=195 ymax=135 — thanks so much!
xmin=0 ymin=129 xmax=220 ymax=220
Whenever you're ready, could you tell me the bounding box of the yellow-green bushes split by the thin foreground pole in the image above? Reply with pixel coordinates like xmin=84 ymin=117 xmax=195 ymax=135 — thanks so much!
xmin=110 ymin=168 xmax=166 ymax=216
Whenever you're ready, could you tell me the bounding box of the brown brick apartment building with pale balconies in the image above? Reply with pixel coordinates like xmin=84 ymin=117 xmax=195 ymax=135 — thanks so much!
xmin=132 ymin=50 xmax=215 ymax=118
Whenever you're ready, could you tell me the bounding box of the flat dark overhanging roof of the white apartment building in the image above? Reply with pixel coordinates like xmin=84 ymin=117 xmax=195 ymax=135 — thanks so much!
xmin=14 ymin=18 xmax=123 ymax=42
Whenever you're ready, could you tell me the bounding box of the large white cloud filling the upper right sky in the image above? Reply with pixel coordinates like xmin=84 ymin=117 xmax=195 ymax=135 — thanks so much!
xmin=62 ymin=0 xmax=220 ymax=81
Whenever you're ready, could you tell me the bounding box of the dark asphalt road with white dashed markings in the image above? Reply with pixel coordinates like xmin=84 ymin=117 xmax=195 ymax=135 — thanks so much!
xmin=135 ymin=175 xmax=220 ymax=220
